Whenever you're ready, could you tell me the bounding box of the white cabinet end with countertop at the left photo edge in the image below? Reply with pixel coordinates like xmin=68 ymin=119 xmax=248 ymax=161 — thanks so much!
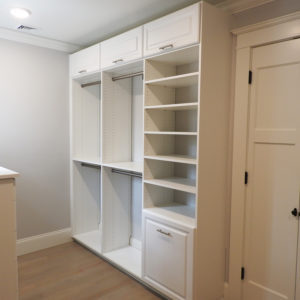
xmin=0 ymin=178 xmax=18 ymax=300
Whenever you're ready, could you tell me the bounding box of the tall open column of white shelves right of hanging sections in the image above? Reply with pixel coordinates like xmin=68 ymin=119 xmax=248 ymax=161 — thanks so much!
xmin=144 ymin=45 xmax=199 ymax=225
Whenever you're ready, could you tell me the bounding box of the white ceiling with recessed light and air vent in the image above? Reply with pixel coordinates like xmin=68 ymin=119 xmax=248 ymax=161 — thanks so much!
xmin=0 ymin=0 xmax=223 ymax=46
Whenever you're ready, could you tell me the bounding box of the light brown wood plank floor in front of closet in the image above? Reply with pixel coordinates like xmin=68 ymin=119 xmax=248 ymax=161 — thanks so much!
xmin=18 ymin=242 xmax=161 ymax=300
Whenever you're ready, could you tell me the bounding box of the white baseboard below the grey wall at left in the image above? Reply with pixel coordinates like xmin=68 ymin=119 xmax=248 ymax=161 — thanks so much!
xmin=17 ymin=228 xmax=72 ymax=256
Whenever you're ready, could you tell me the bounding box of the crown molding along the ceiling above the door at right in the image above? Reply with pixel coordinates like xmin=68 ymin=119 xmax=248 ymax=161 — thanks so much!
xmin=216 ymin=0 xmax=274 ymax=14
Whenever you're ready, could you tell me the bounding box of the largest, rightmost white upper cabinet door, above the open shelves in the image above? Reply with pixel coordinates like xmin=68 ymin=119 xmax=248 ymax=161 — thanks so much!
xmin=144 ymin=3 xmax=200 ymax=56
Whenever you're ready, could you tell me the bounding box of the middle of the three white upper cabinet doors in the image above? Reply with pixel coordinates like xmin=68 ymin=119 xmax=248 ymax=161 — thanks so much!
xmin=101 ymin=26 xmax=143 ymax=68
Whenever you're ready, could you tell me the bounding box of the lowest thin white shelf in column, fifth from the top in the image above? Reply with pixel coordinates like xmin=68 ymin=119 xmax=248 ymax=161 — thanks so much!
xmin=144 ymin=177 xmax=196 ymax=194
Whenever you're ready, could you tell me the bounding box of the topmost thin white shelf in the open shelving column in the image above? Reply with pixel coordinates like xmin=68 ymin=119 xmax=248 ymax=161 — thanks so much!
xmin=145 ymin=72 xmax=199 ymax=88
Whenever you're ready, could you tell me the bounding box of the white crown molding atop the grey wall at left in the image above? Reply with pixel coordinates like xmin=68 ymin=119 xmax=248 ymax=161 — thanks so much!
xmin=0 ymin=27 xmax=80 ymax=53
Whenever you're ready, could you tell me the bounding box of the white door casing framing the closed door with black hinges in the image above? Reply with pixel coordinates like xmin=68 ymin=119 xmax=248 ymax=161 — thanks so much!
xmin=225 ymin=11 xmax=300 ymax=300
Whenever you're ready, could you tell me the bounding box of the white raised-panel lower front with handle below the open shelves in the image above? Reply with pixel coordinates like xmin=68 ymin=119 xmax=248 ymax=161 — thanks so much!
xmin=144 ymin=219 xmax=188 ymax=298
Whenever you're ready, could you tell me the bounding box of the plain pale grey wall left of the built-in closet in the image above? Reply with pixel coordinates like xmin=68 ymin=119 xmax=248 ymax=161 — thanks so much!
xmin=0 ymin=40 xmax=70 ymax=239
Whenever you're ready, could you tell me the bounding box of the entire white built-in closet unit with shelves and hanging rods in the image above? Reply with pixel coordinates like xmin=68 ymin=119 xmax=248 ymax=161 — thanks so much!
xmin=70 ymin=2 xmax=231 ymax=300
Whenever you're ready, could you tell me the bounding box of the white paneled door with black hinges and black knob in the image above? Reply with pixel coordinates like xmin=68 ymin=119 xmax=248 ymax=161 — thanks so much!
xmin=243 ymin=39 xmax=300 ymax=300
